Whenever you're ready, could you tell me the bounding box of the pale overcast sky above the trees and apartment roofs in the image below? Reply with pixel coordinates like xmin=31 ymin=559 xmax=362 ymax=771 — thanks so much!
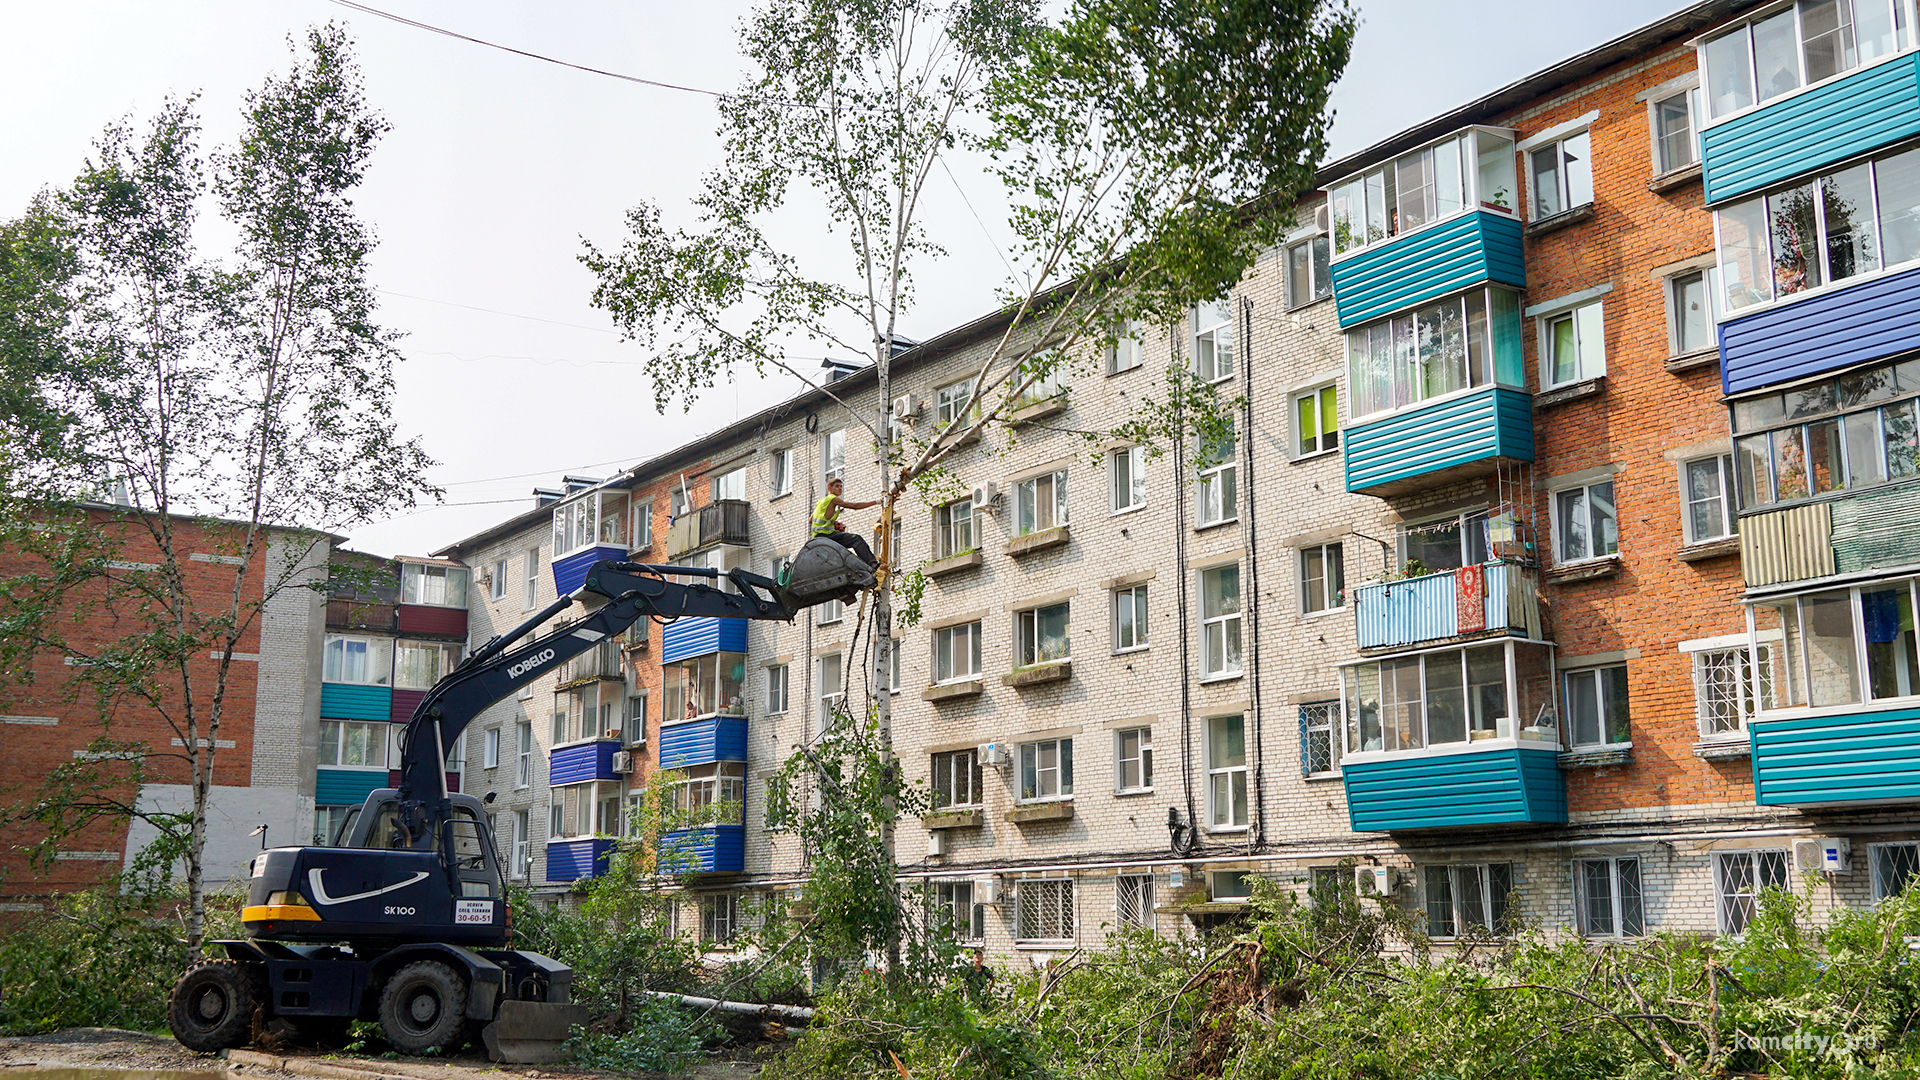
xmin=0 ymin=0 xmax=1684 ymax=555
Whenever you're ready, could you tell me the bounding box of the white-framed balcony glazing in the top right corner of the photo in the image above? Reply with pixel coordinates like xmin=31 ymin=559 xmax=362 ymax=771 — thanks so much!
xmin=1699 ymin=0 xmax=1912 ymax=117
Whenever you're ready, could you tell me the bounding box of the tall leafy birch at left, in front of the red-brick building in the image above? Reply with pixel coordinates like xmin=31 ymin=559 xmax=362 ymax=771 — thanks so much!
xmin=0 ymin=25 xmax=432 ymax=944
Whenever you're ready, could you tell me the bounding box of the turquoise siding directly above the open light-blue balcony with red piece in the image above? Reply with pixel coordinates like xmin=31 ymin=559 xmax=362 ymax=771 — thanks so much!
xmin=1346 ymin=386 xmax=1534 ymax=496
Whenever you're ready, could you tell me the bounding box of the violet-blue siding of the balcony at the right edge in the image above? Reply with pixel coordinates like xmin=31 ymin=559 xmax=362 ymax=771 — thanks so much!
xmin=1720 ymin=267 xmax=1920 ymax=394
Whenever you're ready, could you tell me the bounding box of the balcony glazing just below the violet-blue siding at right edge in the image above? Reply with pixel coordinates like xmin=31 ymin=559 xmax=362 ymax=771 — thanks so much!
xmin=1734 ymin=359 xmax=1920 ymax=509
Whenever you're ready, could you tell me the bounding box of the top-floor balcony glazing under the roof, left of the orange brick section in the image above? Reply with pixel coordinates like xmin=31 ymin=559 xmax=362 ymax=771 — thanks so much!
xmin=1327 ymin=129 xmax=1519 ymax=258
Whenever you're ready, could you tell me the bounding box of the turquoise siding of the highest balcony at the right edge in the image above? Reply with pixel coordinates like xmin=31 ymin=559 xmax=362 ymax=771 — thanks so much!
xmin=1699 ymin=54 xmax=1920 ymax=204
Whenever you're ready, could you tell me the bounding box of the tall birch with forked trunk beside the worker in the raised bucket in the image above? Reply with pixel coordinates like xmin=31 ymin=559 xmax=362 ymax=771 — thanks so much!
xmin=584 ymin=0 xmax=1354 ymax=959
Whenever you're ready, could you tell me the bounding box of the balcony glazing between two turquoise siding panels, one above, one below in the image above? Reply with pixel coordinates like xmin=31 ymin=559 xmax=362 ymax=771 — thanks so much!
xmin=1346 ymin=288 xmax=1526 ymax=417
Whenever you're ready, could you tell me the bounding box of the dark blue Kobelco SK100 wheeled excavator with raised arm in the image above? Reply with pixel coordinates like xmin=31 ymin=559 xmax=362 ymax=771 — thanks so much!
xmin=167 ymin=540 xmax=874 ymax=1061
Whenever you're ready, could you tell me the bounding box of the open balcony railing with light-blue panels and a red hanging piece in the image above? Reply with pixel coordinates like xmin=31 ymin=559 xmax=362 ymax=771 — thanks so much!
xmin=1354 ymin=563 xmax=1540 ymax=650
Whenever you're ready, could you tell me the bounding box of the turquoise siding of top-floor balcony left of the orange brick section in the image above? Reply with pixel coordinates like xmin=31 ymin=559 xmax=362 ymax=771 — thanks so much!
xmin=1332 ymin=209 xmax=1526 ymax=329
